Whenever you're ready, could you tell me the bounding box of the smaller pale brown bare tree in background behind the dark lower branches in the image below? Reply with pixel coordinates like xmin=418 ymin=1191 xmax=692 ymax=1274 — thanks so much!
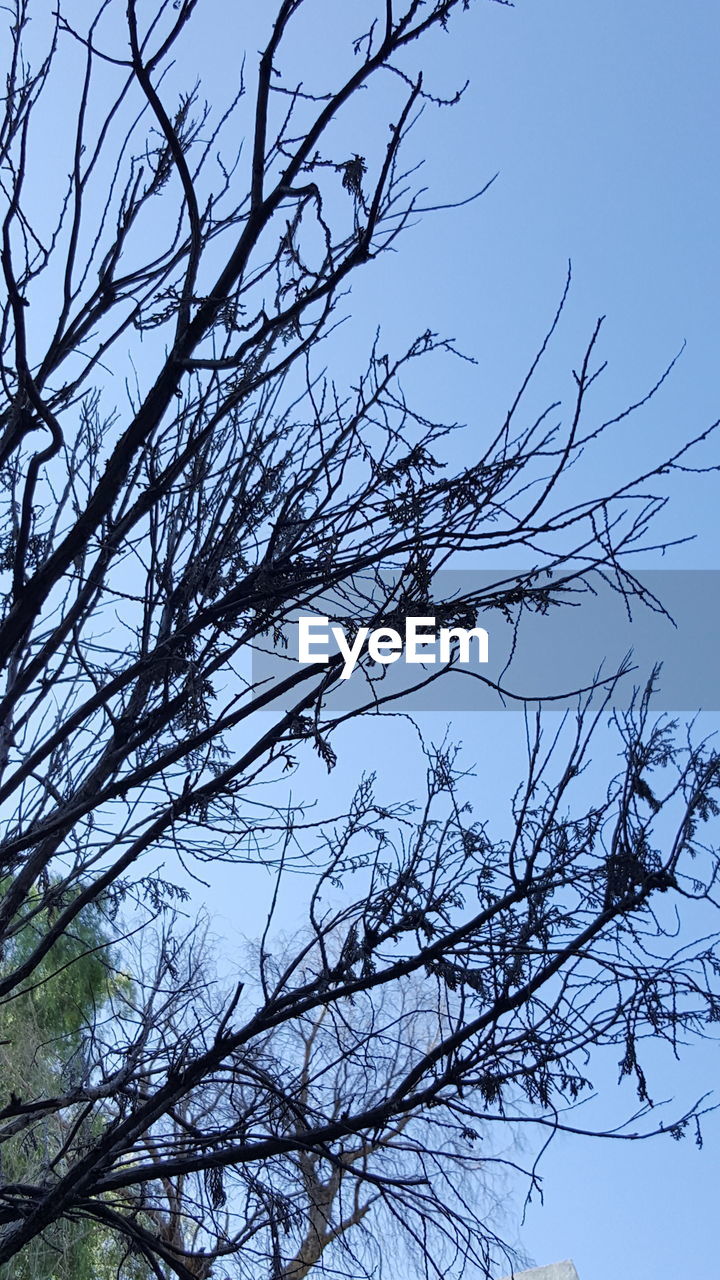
xmin=96 ymin=922 xmax=515 ymax=1280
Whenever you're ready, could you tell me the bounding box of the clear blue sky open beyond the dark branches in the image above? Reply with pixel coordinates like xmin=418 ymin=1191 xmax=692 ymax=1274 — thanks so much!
xmin=162 ymin=0 xmax=720 ymax=1280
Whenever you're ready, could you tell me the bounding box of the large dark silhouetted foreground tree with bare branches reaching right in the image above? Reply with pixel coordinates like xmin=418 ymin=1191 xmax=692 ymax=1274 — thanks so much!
xmin=0 ymin=0 xmax=717 ymax=1280
